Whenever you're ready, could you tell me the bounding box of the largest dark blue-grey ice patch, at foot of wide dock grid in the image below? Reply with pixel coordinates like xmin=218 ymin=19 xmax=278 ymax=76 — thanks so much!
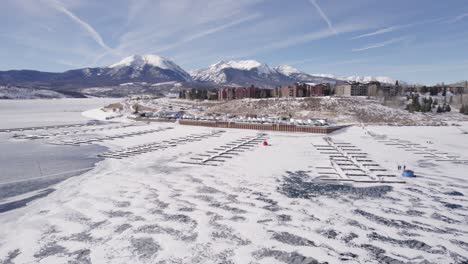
xmin=278 ymin=171 xmax=392 ymax=199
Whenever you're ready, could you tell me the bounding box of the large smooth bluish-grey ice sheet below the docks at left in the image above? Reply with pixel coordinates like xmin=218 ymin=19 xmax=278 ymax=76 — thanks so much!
xmin=0 ymin=135 xmax=105 ymax=199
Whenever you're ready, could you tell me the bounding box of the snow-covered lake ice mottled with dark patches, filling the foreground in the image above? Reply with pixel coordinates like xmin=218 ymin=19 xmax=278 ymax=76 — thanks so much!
xmin=0 ymin=103 xmax=468 ymax=263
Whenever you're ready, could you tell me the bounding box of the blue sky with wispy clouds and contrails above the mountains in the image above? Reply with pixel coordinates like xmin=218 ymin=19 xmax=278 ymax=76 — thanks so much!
xmin=0 ymin=0 xmax=468 ymax=84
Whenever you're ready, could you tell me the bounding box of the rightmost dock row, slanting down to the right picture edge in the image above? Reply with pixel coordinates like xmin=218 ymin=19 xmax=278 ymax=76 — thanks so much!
xmin=369 ymin=132 xmax=468 ymax=165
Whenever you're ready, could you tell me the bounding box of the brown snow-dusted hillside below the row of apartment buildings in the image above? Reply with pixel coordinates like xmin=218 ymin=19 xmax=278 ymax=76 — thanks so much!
xmin=209 ymin=97 xmax=437 ymax=125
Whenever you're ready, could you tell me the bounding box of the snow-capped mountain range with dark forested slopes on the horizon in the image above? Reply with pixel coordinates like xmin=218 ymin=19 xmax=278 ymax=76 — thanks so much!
xmin=0 ymin=55 xmax=393 ymax=97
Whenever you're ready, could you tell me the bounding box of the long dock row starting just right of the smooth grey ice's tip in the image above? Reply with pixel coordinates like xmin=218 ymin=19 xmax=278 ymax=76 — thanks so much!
xmin=98 ymin=130 xmax=225 ymax=159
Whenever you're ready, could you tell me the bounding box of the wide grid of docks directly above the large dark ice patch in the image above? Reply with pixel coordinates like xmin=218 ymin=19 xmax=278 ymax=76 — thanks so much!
xmin=314 ymin=137 xmax=405 ymax=183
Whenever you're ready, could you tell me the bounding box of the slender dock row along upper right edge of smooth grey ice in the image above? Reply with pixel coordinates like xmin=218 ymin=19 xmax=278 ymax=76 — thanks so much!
xmin=50 ymin=127 xmax=172 ymax=146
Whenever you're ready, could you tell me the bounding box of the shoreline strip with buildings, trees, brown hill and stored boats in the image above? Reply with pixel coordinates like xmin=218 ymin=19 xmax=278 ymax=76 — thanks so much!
xmin=107 ymin=81 xmax=468 ymax=131
